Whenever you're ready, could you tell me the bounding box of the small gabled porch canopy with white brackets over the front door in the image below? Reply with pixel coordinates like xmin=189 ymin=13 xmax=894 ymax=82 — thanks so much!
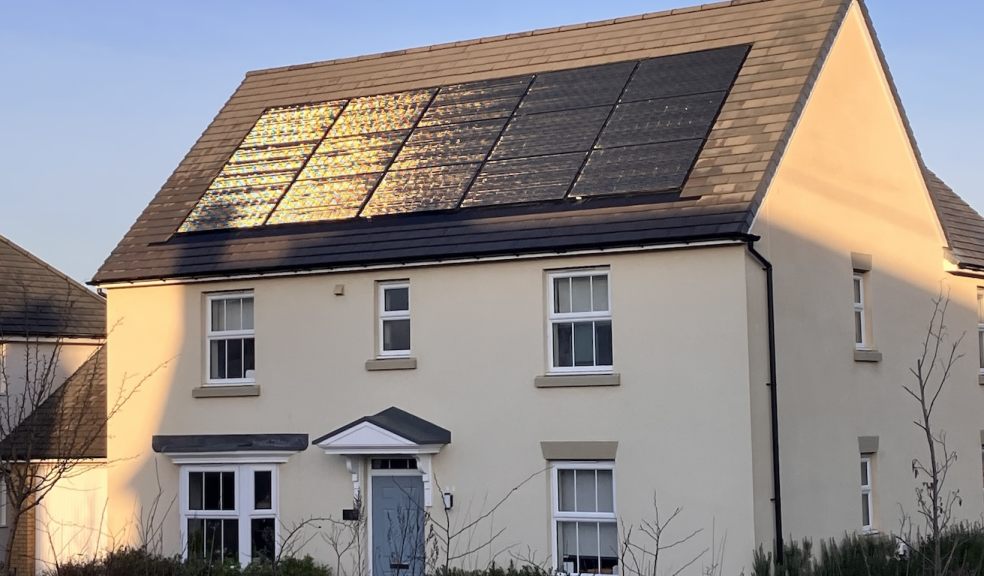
xmin=312 ymin=406 xmax=451 ymax=507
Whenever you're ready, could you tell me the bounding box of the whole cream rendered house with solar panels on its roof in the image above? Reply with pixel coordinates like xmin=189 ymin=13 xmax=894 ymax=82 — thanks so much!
xmin=93 ymin=0 xmax=984 ymax=576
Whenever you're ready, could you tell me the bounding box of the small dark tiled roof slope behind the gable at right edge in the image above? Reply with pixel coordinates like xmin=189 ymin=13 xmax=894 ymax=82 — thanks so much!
xmin=925 ymin=170 xmax=984 ymax=270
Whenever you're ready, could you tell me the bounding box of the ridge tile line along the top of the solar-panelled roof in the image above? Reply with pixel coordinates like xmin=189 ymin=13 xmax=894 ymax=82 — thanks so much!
xmin=246 ymin=0 xmax=775 ymax=77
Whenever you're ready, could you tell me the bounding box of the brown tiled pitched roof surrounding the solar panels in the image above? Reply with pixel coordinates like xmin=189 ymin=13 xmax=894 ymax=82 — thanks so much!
xmin=93 ymin=0 xmax=849 ymax=283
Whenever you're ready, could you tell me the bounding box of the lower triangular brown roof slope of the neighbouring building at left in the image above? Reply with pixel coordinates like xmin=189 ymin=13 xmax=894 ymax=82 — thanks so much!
xmin=0 ymin=346 xmax=106 ymax=461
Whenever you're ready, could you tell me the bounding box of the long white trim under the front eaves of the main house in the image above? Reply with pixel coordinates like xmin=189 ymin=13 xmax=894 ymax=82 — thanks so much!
xmin=98 ymin=240 xmax=746 ymax=290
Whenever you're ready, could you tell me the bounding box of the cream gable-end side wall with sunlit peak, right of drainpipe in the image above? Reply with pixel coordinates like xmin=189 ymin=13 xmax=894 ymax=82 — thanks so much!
xmin=753 ymin=4 xmax=984 ymax=537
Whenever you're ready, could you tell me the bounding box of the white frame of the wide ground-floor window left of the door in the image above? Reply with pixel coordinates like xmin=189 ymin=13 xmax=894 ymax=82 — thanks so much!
xmin=178 ymin=464 xmax=280 ymax=566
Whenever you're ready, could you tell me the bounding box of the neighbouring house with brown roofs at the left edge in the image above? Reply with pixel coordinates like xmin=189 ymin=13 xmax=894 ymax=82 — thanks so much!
xmin=0 ymin=236 xmax=106 ymax=574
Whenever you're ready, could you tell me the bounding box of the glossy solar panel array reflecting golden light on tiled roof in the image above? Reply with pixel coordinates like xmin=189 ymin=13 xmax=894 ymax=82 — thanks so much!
xmin=179 ymin=45 xmax=748 ymax=232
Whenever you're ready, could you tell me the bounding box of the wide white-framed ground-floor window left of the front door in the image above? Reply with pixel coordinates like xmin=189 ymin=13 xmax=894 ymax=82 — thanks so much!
xmin=181 ymin=464 xmax=277 ymax=564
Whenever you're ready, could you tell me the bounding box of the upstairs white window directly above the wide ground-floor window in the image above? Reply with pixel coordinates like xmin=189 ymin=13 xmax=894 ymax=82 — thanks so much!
xmin=206 ymin=292 xmax=256 ymax=384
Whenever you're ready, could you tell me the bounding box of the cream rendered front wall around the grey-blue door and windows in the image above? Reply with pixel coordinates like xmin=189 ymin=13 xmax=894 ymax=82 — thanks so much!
xmin=108 ymin=246 xmax=761 ymax=573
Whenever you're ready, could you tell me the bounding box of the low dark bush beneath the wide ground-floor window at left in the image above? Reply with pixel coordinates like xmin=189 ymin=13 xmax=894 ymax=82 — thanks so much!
xmin=45 ymin=548 xmax=332 ymax=576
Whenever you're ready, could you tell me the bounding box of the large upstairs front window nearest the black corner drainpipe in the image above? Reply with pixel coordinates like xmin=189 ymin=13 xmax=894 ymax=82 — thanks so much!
xmin=547 ymin=270 xmax=612 ymax=372
